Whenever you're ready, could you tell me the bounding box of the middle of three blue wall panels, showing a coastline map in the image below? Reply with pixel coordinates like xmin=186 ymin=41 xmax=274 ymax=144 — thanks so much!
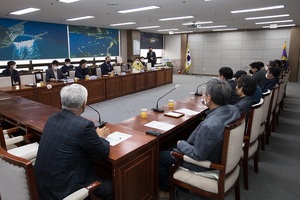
xmin=69 ymin=26 xmax=119 ymax=58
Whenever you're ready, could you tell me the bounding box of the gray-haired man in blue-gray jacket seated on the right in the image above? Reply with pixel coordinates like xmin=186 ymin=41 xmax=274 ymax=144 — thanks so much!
xmin=159 ymin=79 xmax=240 ymax=198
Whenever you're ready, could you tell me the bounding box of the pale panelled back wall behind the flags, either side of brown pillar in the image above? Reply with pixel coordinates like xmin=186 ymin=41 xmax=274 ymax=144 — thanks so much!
xmin=170 ymin=29 xmax=291 ymax=75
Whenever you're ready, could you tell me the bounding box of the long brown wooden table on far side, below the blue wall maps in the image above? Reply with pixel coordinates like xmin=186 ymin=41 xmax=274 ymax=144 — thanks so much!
xmin=0 ymin=68 xmax=173 ymax=108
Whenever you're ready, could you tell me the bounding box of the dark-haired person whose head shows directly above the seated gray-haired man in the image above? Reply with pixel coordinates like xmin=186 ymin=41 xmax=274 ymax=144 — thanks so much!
xmin=219 ymin=67 xmax=239 ymax=105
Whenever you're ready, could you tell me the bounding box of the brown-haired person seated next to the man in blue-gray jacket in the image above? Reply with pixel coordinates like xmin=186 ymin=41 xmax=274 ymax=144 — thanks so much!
xmin=234 ymin=75 xmax=257 ymax=113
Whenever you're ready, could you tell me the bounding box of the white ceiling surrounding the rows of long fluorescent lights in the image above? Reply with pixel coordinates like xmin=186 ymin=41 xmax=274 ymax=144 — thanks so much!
xmin=0 ymin=0 xmax=300 ymax=34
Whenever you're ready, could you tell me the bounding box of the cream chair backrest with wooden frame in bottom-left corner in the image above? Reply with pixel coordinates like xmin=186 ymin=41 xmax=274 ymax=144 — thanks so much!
xmin=0 ymin=147 xmax=38 ymax=200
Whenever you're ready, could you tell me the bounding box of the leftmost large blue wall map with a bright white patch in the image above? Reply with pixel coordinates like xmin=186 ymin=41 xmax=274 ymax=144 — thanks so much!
xmin=0 ymin=18 xmax=68 ymax=60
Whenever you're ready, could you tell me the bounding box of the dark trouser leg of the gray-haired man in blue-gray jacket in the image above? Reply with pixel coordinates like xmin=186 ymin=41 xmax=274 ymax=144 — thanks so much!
xmin=158 ymin=151 xmax=176 ymax=192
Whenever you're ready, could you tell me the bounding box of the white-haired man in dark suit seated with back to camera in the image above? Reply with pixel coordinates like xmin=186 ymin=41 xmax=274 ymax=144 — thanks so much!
xmin=34 ymin=84 xmax=112 ymax=200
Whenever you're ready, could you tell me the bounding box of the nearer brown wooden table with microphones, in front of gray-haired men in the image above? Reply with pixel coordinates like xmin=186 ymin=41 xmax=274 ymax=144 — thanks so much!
xmin=0 ymin=80 xmax=206 ymax=200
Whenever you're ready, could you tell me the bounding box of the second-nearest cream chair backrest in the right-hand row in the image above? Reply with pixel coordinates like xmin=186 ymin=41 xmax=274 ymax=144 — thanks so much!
xmin=246 ymin=98 xmax=264 ymax=144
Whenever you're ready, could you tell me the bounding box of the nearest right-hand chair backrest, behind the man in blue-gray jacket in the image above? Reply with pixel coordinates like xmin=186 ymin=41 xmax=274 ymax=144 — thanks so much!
xmin=221 ymin=114 xmax=245 ymax=174
